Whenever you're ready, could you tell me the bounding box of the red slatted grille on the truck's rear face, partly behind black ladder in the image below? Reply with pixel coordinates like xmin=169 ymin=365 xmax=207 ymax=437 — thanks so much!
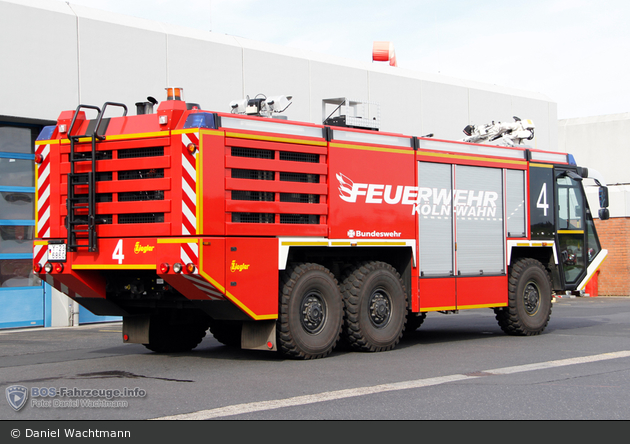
xmin=60 ymin=140 xmax=170 ymax=243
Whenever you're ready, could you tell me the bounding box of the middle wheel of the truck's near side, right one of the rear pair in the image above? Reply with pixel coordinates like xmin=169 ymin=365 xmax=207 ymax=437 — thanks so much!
xmin=341 ymin=262 xmax=407 ymax=352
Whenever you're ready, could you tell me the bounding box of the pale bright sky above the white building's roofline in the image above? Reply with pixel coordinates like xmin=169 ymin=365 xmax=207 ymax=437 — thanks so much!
xmin=60 ymin=0 xmax=630 ymax=119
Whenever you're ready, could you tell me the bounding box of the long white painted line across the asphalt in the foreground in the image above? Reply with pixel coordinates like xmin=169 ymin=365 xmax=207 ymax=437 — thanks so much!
xmin=153 ymin=350 xmax=630 ymax=421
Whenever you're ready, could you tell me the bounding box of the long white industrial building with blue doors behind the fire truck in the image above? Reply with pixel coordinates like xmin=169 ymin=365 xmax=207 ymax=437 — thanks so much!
xmin=0 ymin=0 xmax=627 ymax=328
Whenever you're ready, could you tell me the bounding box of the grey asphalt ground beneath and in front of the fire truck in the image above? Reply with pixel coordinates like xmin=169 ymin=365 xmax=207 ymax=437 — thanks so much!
xmin=0 ymin=297 xmax=630 ymax=424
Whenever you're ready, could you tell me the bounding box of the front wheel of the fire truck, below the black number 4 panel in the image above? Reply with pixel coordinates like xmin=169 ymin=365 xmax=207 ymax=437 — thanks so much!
xmin=495 ymin=258 xmax=552 ymax=336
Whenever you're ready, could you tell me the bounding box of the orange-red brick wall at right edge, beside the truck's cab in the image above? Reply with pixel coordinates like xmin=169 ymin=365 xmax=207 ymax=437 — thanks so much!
xmin=595 ymin=217 xmax=630 ymax=296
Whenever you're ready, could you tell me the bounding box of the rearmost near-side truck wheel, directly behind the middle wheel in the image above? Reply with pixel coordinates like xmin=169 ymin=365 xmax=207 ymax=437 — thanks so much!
xmin=277 ymin=263 xmax=343 ymax=359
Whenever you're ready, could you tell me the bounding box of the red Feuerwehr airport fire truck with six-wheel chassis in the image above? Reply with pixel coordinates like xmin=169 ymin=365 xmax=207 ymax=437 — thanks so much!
xmin=34 ymin=88 xmax=607 ymax=359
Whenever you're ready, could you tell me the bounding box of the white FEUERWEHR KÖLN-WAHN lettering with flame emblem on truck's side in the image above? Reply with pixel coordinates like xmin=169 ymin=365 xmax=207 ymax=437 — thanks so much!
xmin=335 ymin=173 xmax=499 ymax=217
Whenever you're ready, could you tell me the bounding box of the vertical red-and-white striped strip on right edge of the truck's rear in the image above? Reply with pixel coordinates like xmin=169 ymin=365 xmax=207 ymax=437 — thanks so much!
xmin=182 ymin=134 xmax=199 ymax=235
